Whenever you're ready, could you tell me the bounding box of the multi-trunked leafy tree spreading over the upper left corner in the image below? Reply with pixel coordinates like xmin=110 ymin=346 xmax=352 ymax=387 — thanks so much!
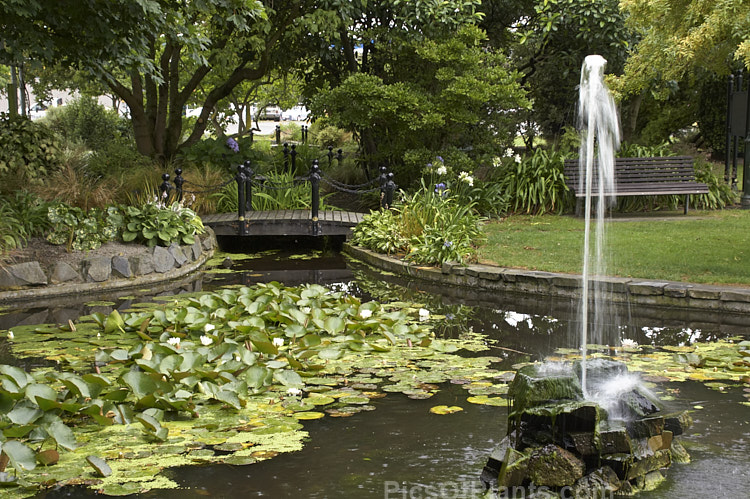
xmin=0 ymin=0 xmax=313 ymax=161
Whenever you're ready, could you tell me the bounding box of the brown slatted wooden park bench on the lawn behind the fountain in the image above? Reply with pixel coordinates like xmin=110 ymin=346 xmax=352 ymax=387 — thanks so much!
xmin=564 ymin=156 xmax=708 ymax=214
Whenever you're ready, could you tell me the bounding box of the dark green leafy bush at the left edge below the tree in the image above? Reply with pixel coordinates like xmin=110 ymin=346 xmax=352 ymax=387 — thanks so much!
xmin=0 ymin=113 xmax=59 ymax=192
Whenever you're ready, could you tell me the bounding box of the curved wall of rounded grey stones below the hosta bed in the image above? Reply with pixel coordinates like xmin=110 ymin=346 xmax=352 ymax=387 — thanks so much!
xmin=0 ymin=227 xmax=217 ymax=303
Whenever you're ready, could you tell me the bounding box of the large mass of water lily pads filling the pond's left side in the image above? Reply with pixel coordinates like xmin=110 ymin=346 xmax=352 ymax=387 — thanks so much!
xmin=0 ymin=283 xmax=507 ymax=497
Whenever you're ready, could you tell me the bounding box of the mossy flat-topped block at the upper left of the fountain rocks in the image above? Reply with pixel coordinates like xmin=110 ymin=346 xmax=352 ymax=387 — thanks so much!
xmin=508 ymin=363 xmax=583 ymax=413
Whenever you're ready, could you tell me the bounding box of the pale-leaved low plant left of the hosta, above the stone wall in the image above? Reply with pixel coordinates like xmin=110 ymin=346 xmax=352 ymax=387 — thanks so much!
xmin=47 ymin=203 xmax=123 ymax=252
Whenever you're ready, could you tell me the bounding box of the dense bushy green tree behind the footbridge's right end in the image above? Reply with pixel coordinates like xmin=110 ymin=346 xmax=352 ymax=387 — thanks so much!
xmin=287 ymin=0 xmax=525 ymax=178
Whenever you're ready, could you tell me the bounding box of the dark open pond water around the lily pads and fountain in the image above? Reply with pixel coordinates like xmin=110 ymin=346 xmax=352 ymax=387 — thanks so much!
xmin=0 ymin=244 xmax=750 ymax=499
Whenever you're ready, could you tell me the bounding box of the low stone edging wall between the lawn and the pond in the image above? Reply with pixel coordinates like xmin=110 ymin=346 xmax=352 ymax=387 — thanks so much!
xmin=344 ymin=244 xmax=750 ymax=315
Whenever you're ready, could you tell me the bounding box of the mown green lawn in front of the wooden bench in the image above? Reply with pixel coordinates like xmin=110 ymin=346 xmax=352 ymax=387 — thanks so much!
xmin=479 ymin=209 xmax=750 ymax=285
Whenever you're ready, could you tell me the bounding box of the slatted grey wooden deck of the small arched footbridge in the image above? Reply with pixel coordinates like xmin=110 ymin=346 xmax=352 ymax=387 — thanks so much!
xmin=202 ymin=210 xmax=365 ymax=236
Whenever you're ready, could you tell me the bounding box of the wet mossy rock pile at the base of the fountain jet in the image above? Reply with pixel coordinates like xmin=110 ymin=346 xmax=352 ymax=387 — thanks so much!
xmin=481 ymin=359 xmax=692 ymax=498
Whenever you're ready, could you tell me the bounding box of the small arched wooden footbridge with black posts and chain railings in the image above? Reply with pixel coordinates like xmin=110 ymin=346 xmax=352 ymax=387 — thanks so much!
xmin=161 ymin=160 xmax=396 ymax=237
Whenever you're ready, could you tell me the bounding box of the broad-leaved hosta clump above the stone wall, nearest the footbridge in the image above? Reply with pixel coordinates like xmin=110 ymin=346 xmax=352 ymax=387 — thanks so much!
xmin=122 ymin=203 xmax=203 ymax=247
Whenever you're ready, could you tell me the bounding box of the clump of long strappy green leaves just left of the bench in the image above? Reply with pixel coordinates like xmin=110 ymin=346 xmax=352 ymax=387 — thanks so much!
xmin=493 ymin=148 xmax=572 ymax=214
